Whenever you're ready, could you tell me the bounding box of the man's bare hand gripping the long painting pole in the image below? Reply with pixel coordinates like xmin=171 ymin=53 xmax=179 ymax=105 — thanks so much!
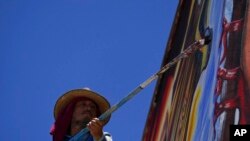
xmin=87 ymin=118 xmax=104 ymax=141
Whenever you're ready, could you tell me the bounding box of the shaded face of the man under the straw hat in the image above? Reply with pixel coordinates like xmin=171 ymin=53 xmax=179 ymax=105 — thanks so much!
xmin=72 ymin=99 xmax=97 ymax=122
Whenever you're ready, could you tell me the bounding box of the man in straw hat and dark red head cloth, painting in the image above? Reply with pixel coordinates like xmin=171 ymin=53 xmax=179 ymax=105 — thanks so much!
xmin=51 ymin=88 xmax=112 ymax=141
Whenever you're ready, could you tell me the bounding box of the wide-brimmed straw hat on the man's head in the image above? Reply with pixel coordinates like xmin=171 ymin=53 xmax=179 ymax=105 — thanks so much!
xmin=54 ymin=88 xmax=111 ymax=124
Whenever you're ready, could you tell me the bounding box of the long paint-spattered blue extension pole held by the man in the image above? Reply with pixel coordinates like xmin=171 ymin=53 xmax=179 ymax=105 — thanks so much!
xmin=69 ymin=39 xmax=209 ymax=141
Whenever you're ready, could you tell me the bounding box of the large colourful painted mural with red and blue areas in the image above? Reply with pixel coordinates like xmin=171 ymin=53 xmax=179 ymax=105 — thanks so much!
xmin=142 ymin=0 xmax=250 ymax=141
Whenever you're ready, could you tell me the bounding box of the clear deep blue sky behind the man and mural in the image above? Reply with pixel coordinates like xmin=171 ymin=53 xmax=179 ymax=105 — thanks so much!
xmin=0 ymin=0 xmax=178 ymax=141
